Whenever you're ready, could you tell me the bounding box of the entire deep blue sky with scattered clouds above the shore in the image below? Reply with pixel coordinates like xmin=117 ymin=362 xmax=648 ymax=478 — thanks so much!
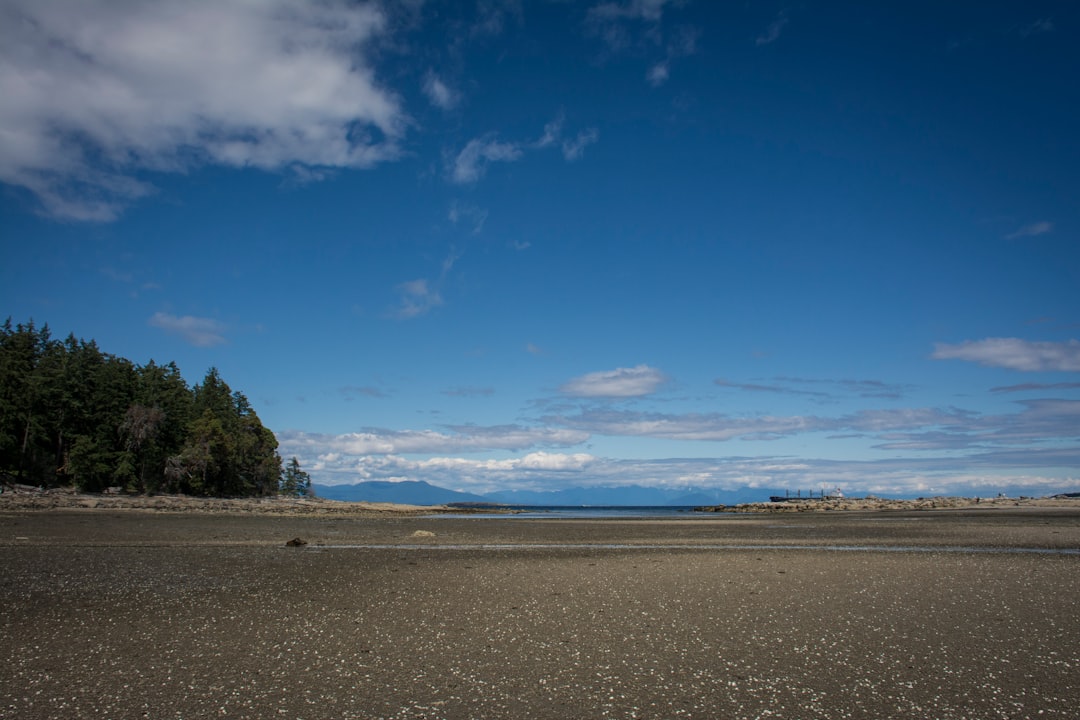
xmin=0 ymin=0 xmax=1080 ymax=495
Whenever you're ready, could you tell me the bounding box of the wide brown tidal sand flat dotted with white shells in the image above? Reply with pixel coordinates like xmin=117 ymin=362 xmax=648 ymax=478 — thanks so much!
xmin=0 ymin=507 xmax=1080 ymax=719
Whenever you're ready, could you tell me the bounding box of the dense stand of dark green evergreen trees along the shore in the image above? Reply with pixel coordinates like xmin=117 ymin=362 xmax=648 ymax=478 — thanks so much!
xmin=0 ymin=318 xmax=311 ymax=497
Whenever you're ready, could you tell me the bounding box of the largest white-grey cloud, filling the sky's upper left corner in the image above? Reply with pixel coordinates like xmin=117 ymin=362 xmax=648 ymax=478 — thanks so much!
xmin=0 ymin=0 xmax=407 ymax=221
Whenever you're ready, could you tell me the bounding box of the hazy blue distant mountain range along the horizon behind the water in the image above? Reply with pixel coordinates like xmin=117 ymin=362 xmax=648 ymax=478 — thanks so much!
xmin=313 ymin=480 xmax=784 ymax=506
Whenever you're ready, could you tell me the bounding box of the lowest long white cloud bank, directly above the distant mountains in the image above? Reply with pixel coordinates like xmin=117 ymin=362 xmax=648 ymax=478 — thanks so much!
xmin=283 ymin=443 xmax=1080 ymax=500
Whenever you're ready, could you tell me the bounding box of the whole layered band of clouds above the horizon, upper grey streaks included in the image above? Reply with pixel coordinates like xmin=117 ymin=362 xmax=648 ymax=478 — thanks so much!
xmin=278 ymin=399 xmax=1080 ymax=495
